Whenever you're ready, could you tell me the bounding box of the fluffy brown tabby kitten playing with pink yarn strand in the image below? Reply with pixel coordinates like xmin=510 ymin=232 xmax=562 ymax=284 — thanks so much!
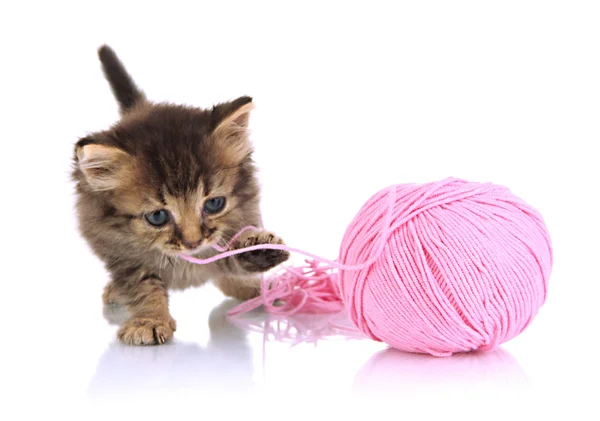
xmin=73 ymin=46 xmax=289 ymax=345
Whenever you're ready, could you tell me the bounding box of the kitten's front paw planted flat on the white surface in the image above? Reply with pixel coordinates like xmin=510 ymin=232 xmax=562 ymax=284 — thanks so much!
xmin=117 ymin=316 xmax=177 ymax=345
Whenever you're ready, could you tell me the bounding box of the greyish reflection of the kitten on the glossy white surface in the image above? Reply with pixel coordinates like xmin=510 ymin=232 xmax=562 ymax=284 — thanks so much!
xmin=88 ymin=300 xmax=255 ymax=399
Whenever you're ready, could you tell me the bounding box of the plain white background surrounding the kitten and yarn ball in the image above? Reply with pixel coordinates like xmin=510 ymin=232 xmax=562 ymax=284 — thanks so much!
xmin=0 ymin=0 xmax=600 ymax=420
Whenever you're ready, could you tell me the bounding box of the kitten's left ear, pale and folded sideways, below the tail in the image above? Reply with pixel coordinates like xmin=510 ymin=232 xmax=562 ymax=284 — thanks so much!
xmin=75 ymin=137 xmax=131 ymax=191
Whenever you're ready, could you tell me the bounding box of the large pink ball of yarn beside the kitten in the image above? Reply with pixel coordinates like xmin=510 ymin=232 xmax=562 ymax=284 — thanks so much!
xmin=339 ymin=179 xmax=552 ymax=356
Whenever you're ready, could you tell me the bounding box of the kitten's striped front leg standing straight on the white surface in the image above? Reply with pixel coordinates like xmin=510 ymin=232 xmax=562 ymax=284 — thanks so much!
xmin=103 ymin=277 xmax=176 ymax=345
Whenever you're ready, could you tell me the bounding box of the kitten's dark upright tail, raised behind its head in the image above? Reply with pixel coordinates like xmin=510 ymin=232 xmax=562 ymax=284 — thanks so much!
xmin=98 ymin=45 xmax=146 ymax=114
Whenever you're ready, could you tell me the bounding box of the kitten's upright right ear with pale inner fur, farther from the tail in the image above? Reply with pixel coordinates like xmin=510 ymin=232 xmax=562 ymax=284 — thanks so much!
xmin=212 ymin=96 xmax=254 ymax=165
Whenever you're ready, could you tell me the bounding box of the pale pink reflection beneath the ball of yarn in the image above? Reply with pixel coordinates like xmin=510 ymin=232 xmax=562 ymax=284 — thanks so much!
xmin=354 ymin=348 xmax=528 ymax=397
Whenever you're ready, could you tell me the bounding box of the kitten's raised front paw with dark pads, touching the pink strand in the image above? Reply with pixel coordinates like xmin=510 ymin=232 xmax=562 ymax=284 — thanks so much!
xmin=235 ymin=231 xmax=290 ymax=272
